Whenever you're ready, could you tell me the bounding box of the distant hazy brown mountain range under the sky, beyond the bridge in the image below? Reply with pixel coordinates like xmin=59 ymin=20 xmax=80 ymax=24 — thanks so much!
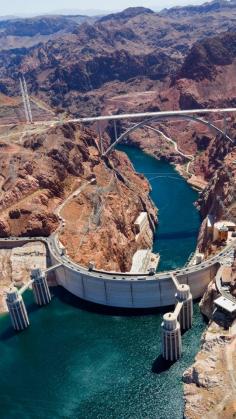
xmin=0 ymin=1 xmax=236 ymax=115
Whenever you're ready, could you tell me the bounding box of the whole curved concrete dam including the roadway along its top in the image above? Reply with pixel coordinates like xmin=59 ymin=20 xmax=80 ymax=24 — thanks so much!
xmin=0 ymin=234 xmax=236 ymax=308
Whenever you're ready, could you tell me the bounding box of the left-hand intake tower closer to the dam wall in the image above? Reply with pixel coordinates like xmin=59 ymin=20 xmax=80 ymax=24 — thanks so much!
xmin=31 ymin=269 xmax=52 ymax=306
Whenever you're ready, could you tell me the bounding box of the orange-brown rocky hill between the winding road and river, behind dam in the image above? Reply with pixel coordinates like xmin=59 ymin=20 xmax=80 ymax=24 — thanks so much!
xmin=60 ymin=148 xmax=156 ymax=272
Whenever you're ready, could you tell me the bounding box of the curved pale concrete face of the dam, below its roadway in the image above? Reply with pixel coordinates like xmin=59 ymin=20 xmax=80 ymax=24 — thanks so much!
xmin=52 ymin=260 xmax=219 ymax=308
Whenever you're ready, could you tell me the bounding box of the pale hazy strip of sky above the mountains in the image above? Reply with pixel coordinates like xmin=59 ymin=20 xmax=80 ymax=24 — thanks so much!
xmin=0 ymin=0 xmax=208 ymax=16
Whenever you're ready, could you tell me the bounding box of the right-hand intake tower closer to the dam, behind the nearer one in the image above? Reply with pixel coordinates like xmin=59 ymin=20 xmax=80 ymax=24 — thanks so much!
xmin=175 ymin=284 xmax=193 ymax=331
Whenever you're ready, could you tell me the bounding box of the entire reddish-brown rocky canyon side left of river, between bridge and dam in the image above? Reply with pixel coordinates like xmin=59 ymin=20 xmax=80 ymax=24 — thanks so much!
xmin=0 ymin=121 xmax=157 ymax=271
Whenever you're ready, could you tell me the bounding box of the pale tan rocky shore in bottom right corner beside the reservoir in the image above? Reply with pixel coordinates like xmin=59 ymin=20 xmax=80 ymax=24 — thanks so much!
xmin=183 ymin=322 xmax=236 ymax=419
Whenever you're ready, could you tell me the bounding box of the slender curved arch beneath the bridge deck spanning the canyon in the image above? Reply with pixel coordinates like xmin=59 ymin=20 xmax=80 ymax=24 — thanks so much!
xmin=103 ymin=114 xmax=234 ymax=156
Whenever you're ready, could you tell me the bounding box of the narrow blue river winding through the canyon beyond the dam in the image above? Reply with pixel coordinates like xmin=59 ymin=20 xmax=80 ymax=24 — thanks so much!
xmin=119 ymin=145 xmax=200 ymax=271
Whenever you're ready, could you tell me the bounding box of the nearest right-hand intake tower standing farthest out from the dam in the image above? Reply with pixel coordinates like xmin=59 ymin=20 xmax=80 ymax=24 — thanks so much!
xmin=161 ymin=313 xmax=182 ymax=362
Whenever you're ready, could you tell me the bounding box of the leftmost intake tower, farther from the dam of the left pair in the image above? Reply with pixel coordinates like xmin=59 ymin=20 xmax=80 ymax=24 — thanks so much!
xmin=6 ymin=287 xmax=30 ymax=331
